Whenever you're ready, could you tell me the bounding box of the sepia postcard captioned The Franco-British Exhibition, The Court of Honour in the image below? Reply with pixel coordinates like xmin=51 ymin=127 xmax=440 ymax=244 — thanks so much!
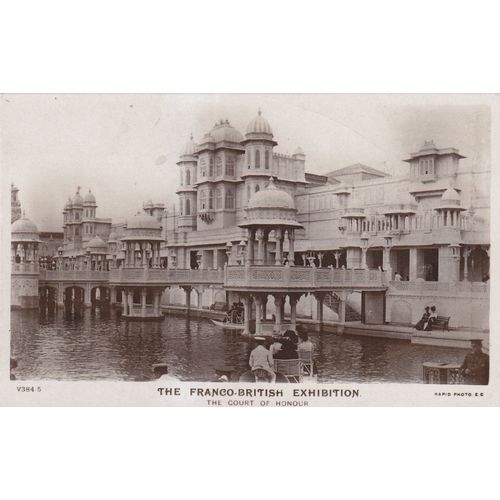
xmin=0 ymin=94 xmax=500 ymax=407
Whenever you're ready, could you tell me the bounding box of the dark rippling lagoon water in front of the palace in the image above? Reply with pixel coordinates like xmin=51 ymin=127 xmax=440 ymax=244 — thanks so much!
xmin=11 ymin=308 xmax=464 ymax=382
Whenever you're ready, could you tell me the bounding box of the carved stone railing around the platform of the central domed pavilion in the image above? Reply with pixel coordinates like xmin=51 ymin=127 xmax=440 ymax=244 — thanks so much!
xmin=224 ymin=266 xmax=386 ymax=290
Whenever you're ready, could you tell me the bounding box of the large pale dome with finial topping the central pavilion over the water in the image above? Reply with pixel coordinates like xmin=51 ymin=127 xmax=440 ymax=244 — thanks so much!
xmin=239 ymin=177 xmax=302 ymax=227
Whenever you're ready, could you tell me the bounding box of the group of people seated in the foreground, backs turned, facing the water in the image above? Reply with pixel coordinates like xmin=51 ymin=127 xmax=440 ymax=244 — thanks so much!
xmin=248 ymin=326 xmax=313 ymax=382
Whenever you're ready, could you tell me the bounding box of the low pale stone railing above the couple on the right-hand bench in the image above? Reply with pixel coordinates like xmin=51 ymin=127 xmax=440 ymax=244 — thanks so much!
xmin=388 ymin=281 xmax=490 ymax=295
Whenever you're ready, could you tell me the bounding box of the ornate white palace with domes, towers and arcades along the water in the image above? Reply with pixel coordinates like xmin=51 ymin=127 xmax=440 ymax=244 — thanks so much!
xmin=12 ymin=112 xmax=490 ymax=332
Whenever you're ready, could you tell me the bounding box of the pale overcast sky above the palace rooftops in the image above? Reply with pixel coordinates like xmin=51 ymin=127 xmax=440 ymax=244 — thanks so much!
xmin=0 ymin=94 xmax=490 ymax=230
